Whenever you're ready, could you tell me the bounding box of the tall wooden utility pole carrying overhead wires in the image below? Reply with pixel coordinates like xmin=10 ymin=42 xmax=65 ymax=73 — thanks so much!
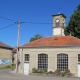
xmin=15 ymin=21 xmax=21 ymax=73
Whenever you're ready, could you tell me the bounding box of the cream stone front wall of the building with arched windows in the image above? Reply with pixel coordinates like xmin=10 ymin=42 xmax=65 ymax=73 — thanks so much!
xmin=19 ymin=47 xmax=80 ymax=76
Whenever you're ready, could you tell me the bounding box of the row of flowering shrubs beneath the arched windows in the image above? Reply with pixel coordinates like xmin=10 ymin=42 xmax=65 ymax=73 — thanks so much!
xmin=32 ymin=68 xmax=73 ymax=77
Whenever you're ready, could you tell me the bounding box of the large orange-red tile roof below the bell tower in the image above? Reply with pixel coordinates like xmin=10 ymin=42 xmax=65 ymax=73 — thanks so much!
xmin=22 ymin=36 xmax=80 ymax=47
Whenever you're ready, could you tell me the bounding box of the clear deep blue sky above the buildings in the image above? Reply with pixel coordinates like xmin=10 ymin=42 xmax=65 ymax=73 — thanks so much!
xmin=0 ymin=0 xmax=80 ymax=47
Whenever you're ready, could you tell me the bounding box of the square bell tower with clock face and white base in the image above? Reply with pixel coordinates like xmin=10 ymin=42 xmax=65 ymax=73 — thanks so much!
xmin=52 ymin=13 xmax=66 ymax=36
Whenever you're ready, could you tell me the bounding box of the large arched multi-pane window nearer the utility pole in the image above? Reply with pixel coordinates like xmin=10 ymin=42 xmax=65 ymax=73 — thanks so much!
xmin=38 ymin=54 xmax=48 ymax=70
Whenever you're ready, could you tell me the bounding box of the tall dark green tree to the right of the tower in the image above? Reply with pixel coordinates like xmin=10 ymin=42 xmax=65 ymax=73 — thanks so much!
xmin=64 ymin=4 xmax=80 ymax=38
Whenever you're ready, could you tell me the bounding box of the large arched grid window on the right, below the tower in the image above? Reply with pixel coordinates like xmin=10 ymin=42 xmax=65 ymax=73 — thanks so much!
xmin=57 ymin=54 xmax=68 ymax=71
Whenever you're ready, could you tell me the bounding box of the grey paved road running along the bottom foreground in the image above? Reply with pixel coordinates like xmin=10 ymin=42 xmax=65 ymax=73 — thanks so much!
xmin=0 ymin=70 xmax=80 ymax=80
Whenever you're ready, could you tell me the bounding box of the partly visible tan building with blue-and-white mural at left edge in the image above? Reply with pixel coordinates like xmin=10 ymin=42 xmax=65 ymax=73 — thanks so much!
xmin=0 ymin=42 xmax=13 ymax=66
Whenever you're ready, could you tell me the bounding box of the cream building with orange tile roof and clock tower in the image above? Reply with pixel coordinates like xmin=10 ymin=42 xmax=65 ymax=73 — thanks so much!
xmin=19 ymin=14 xmax=80 ymax=77
